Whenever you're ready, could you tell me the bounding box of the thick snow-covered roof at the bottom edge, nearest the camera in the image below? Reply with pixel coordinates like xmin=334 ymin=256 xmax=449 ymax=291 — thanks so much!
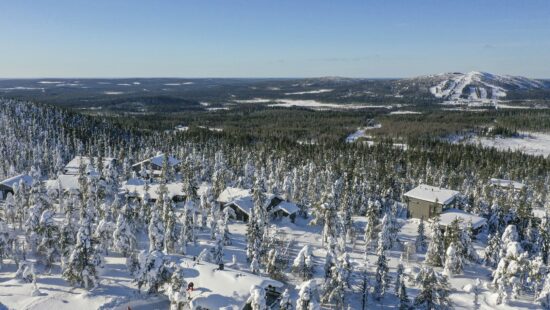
xmin=181 ymin=258 xmax=283 ymax=309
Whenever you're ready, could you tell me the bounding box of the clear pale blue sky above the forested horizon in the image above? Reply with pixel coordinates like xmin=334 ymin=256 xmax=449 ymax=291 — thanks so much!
xmin=0 ymin=0 xmax=550 ymax=78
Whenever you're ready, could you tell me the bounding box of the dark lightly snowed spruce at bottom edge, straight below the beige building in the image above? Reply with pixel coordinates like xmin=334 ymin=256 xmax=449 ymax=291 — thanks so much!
xmin=414 ymin=267 xmax=452 ymax=310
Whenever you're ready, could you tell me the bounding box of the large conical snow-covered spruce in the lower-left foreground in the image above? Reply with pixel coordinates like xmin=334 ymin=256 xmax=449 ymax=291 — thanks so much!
xmin=63 ymin=208 xmax=101 ymax=289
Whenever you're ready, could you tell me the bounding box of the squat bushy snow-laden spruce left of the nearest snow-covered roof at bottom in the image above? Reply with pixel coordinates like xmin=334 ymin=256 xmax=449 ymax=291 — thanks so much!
xmin=135 ymin=249 xmax=170 ymax=294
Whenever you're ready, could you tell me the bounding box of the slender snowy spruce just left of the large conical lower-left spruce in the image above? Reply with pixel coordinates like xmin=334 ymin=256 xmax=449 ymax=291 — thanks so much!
xmin=38 ymin=210 xmax=59 ymax=270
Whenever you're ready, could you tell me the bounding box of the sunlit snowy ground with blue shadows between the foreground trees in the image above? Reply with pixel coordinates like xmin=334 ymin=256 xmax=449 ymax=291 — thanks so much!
xmin=0 ymin=208 xmax=537 ymax=310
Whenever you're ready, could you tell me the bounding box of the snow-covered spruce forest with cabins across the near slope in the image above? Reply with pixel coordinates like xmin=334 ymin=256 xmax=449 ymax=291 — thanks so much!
xmin=0 ymin=99 xmax=550 ymax=310
